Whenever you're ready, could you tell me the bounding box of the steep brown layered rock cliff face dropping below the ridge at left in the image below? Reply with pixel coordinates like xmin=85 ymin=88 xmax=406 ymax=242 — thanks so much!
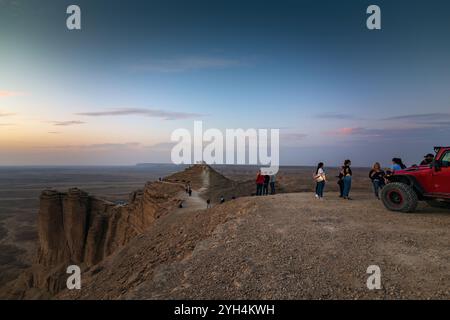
xmin=16 ymin=182 xmax=183 ymax=298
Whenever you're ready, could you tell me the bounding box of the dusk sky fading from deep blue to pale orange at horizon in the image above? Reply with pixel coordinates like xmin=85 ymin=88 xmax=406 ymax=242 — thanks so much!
xmin=0 ymin=0 xmax=450 ymax=166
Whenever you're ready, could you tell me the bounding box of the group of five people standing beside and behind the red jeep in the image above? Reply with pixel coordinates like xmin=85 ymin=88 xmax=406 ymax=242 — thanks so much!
xmin=313 ymin=153 xmax=434 ymax=200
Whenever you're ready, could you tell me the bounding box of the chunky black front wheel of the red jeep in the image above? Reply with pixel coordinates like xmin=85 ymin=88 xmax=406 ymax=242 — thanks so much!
xmin=381 ymin=182 xmax=418 ymax=212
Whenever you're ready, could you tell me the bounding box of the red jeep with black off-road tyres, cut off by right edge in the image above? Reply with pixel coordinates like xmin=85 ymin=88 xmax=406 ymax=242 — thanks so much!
xmin=381 ymin=147 xmax=450 ymax=212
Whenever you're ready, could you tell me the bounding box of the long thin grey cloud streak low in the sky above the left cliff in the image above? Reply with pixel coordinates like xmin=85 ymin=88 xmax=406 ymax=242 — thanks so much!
xmin=76 ymin=108 xmax=204 ymax=120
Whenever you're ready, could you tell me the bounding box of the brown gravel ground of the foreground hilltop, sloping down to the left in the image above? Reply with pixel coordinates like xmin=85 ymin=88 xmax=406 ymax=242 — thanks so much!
xmin=56 ymin=193 xmax=450 ymax=299
